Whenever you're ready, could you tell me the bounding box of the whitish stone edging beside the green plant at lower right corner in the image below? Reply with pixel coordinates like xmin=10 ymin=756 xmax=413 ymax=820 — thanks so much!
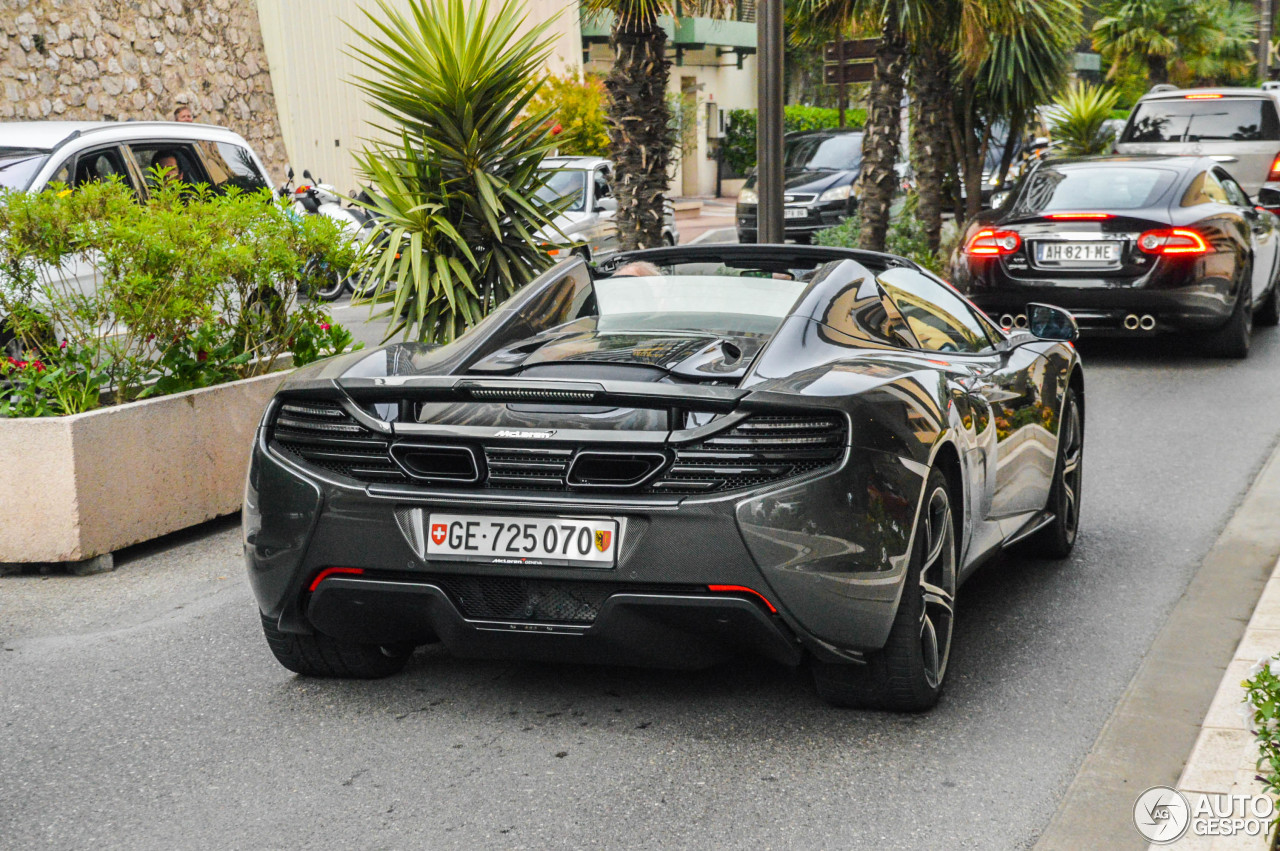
xmin=1149 ymin=562 xmax=1280 ymax=851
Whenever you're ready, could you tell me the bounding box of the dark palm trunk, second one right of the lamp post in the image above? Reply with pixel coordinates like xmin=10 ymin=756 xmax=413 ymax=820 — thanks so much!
xmin=911 ymin=44 xmax=952 ymax=251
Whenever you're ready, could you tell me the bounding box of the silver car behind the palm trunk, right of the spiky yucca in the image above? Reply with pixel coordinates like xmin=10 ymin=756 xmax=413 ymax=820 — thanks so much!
xmin=539 ymin=156 xmax=680 ymax=262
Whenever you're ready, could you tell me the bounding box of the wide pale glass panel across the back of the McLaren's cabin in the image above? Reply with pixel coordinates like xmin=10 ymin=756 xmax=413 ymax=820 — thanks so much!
xmin=594 ymin=275 xmax=806 ymax=335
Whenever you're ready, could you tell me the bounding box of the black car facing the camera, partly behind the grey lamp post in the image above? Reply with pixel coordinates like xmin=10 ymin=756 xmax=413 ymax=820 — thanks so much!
xmin=736 ymin=129 xmax=865 ymax=243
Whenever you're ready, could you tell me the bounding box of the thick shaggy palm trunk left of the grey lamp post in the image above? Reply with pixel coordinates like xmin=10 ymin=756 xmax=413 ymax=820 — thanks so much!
xmin=604 ymin=15 xmax=673 ymax=251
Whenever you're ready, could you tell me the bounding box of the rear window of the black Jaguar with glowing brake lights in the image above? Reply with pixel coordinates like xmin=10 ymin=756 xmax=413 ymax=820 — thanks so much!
xmin=1014 ymin=165 xmax=1178 ymax=214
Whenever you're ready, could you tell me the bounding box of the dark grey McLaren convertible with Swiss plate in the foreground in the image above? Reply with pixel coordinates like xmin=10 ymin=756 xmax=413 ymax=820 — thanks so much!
xmin=243 ymin=246 xmax=1084 ymax=710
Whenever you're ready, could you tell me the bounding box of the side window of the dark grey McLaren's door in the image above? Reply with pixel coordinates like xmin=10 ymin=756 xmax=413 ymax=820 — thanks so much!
xmin=877 ymin=269 xmax=991 ymax=353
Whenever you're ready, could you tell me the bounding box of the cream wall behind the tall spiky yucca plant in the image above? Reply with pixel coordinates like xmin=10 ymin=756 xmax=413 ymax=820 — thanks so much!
xmin=257 ymin=0 xmax=582 ymax=192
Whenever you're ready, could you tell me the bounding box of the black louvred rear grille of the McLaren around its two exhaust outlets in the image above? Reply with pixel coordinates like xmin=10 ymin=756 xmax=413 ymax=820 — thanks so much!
xmin=270 ymin=402 xmax=847 ymax=494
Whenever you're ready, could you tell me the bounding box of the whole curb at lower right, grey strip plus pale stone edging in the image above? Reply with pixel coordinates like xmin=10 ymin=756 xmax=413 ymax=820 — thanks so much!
xmin=1034 ymin=437 xmax=1280 ymax=851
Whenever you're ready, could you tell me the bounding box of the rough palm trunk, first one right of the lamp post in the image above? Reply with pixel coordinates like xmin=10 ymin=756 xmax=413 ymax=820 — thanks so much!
xmin=858 ymin=17 xmax=906 ymax=251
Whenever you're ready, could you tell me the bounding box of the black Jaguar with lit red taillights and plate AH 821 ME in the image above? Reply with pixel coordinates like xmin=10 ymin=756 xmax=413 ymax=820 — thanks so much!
xmin=952 ymin=156 xmax=1280 ymax=357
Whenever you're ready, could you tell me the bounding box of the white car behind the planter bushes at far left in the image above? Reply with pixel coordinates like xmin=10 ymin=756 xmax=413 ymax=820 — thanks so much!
xmin=0 ymin=122 xmax=270 ymax=351
